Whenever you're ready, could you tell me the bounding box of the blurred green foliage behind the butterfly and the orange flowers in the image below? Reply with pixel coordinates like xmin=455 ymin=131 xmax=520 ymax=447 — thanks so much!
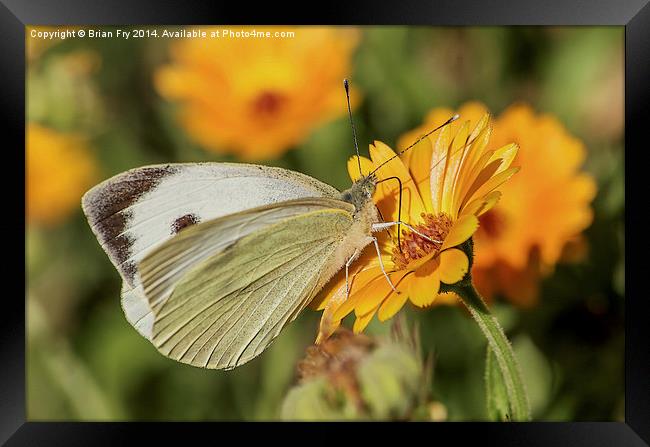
xmin=26 ymin=27 xmax=625 ymax=420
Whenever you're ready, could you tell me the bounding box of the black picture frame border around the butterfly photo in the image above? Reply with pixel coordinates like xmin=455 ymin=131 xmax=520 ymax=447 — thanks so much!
xmin=6 ymin=0 xmax=650 ymax=446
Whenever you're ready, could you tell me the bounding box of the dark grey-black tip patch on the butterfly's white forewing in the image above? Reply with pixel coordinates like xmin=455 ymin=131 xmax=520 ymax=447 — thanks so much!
xmin=83 ymin=165 xmax=177 ymax=280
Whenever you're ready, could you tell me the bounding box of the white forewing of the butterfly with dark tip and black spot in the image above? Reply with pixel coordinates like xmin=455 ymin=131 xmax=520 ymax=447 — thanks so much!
xmin=82 ymin=163 xmax=339 ymax=338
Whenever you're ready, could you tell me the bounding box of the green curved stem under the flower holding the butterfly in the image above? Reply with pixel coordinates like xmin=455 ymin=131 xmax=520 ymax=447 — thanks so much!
xmin=449 ymin=282 xmax=530 ymax=421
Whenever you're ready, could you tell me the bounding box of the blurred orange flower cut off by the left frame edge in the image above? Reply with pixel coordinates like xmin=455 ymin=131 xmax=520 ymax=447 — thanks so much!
xmin=26 ymin=123 xmax=96 ymax=225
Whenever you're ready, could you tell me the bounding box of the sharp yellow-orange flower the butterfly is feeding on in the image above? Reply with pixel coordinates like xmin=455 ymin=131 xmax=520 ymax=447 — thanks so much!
xmin=314 ymin=114 xmax=519 ymax=341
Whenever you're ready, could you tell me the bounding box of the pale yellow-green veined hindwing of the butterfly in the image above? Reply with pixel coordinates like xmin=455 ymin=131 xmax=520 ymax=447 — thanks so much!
xmin=139 ymin=198 xmax=353 ymax=369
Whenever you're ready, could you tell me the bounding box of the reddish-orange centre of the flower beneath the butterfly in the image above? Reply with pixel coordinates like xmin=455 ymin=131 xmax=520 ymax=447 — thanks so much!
xmin=393 ymin=213 xmax=453 ymax=270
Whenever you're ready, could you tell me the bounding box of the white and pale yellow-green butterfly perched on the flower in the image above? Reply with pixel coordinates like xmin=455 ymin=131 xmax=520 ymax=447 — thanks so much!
xmin=82 ymin=93 xmax=457 ymax=369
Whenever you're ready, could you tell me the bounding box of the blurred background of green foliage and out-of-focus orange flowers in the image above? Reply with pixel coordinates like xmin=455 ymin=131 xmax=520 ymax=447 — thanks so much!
xmin=25 ymin=27 xmax=625 ymax=421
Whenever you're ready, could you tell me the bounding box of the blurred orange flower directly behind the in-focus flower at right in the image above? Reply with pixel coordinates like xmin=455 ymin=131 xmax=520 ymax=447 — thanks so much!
xmin=398 ymin=102 xmax=596 ymax=306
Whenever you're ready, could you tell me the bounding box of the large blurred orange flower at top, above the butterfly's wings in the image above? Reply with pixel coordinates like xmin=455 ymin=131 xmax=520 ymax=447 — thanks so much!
xmin=155 ymin=27 xmax=359 ymax=160
